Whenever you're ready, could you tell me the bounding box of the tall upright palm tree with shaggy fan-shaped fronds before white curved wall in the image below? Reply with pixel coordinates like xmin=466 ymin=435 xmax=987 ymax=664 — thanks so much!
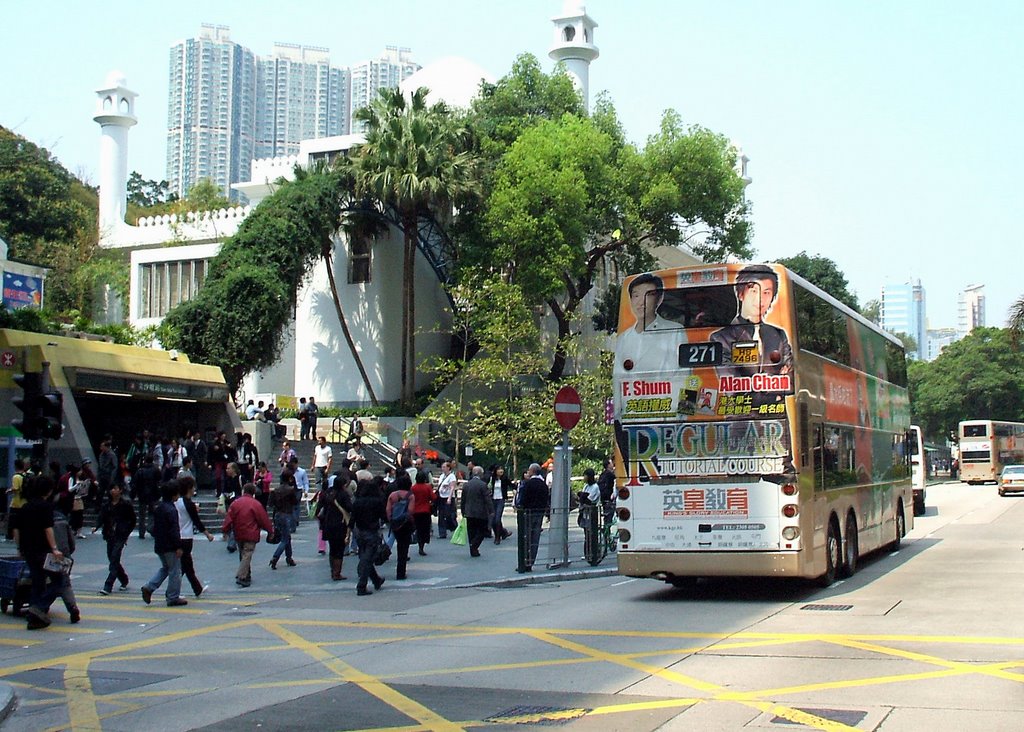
xmin=349 ymin=87 xmax=476 ymax=407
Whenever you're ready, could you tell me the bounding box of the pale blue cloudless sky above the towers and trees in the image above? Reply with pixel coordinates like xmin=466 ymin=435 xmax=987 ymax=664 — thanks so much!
xmin=0 ymin=0 xmax=1024 ymax=328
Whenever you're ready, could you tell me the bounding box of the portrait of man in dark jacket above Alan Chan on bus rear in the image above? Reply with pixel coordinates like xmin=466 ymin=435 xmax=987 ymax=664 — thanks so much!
xmin=711 ymin=264 xmax=793 ymax=380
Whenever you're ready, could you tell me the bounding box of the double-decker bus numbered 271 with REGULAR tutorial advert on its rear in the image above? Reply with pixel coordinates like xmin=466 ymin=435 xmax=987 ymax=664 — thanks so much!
xmin=612 ymin=264 xmax=913 ymax=587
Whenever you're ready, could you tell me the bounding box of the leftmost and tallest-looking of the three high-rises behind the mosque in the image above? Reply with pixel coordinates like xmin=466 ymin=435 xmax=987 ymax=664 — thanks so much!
xmin=167 ymin=25 xmax=256 ymax=200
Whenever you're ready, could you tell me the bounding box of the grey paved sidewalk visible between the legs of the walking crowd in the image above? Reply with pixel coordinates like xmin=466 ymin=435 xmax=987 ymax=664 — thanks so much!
xmin=0 ymin=513 xmax=616 ymax=614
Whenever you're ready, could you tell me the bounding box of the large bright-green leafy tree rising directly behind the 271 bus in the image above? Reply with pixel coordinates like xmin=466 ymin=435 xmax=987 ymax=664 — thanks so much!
xmin=463 ymin=100 xmax=750 ymax=381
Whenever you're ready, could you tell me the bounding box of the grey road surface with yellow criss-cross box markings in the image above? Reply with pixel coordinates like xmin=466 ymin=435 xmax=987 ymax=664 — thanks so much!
xmin=0 ymin=483 xmax=1024 ymax=732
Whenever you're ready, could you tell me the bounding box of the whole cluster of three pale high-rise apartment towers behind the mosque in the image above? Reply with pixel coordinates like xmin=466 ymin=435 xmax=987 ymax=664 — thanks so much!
xmin=167 ymin=25 xmax=407 ymax=201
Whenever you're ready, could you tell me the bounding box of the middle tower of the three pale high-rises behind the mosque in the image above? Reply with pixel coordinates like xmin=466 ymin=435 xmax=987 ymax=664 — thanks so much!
xmin=256 ymin=43 xmax=348 ymax=158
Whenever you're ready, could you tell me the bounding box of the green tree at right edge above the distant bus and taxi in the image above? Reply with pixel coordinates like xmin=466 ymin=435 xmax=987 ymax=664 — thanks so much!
xmin=908 ymin=328 xmax=1024 ymax=436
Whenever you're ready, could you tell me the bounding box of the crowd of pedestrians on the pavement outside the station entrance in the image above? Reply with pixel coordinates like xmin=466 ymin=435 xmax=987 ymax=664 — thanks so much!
xmin=8 ymin=415 xmax=614 ymax=630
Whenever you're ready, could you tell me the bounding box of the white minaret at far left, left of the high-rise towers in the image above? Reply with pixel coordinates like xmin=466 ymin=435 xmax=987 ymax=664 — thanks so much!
xmin=92 ymin=72 xmax=138 ymax=239
